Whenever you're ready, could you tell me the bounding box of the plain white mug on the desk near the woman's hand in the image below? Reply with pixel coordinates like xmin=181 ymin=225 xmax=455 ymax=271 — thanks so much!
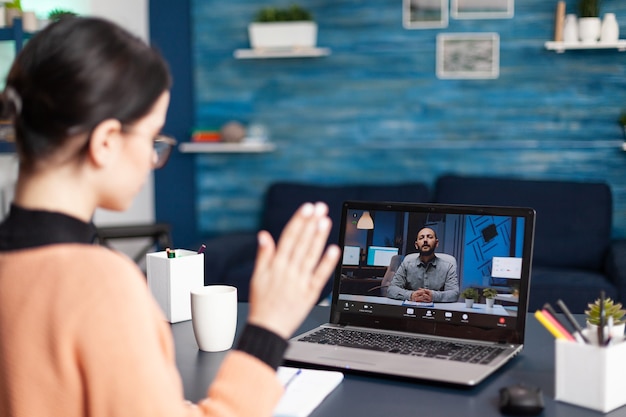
xmin=191 ymin=285 xmax=237 ymax=352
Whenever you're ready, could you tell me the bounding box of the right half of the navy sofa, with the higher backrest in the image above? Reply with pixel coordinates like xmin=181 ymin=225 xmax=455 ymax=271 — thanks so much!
xmin=433 ymin=175 xmax=626 ymax=313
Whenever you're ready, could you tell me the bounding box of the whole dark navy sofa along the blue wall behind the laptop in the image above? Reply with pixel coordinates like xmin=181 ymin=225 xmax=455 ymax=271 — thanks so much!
xmin=205 ymin=175 xmax=626 ymax=313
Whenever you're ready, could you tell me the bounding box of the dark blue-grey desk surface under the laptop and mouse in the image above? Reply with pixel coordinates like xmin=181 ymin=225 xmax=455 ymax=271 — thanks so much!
xmin=172 ymin=304 xmax=626 ymax=417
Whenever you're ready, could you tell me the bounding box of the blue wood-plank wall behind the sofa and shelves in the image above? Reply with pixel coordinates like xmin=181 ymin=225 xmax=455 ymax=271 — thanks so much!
xmin=152 ymin=0 xmax=626 ymax=244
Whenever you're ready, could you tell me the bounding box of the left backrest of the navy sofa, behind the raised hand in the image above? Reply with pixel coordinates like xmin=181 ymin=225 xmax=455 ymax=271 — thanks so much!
xmin=261 ymin=182 xmax=430 ymax=243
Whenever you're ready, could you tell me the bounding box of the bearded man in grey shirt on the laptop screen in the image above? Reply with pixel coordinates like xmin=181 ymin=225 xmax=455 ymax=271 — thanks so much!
xmin=387 ymin=227 xmax=459 ymax=303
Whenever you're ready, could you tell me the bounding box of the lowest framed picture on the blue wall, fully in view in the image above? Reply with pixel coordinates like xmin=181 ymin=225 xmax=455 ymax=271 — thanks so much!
xmin=437 ymin=33 xmax=500 ymax=79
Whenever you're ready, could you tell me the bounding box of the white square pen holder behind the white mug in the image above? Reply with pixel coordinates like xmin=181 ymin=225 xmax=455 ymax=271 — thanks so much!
xmin=146 ymin=249 xmax=204 ymax=323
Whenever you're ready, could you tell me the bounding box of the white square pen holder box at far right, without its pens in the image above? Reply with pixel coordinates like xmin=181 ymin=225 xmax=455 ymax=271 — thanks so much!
xmin=555 ymin=339 xmax=626 ymax=413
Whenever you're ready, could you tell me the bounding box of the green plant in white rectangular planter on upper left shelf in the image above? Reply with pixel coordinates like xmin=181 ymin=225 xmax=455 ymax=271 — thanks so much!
xmin=248 ymin=4 xmax=317 ymax=49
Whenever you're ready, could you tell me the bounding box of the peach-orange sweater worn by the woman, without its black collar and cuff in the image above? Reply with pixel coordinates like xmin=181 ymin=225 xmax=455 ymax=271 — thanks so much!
xmin=0 ymin=244 xmax=283 ymax=417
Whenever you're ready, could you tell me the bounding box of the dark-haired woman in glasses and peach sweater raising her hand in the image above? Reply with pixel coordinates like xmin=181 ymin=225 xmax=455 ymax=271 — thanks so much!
xmin=0 ymin=18 xmax=339 ymax=417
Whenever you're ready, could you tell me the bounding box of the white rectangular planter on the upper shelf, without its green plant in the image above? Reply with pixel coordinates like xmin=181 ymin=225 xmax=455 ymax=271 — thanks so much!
xmin=248 ymin=22 xmax=317 ymax=49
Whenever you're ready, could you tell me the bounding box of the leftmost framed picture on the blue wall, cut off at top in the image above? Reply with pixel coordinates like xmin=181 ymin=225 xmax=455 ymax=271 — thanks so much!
xmin=402 ymin=0 xmax=448 ymax=29
